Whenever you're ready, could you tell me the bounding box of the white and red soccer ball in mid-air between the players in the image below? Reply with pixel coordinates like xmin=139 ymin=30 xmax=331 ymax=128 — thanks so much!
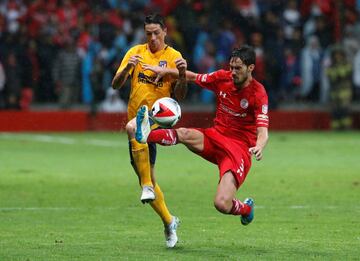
xmin=150 ymin=97 xmax=181 ymax=128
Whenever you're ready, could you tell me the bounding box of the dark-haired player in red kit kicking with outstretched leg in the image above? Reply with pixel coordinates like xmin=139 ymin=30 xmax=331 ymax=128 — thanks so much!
xmin=136 ymin=46 xmax=269 ymax=225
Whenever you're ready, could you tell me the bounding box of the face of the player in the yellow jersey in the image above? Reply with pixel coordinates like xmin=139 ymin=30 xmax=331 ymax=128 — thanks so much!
xmin=145 ymin=24 xmax=166 ymax=53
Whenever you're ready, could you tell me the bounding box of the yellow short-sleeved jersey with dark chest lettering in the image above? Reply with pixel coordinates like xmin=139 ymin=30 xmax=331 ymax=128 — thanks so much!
xmin=117 ymin=44 xmax=182 ymax=120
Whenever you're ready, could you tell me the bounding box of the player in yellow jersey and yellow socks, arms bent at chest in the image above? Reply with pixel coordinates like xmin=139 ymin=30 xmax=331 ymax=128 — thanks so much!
xmin=112 ymin=14 xmax=187 ymax=248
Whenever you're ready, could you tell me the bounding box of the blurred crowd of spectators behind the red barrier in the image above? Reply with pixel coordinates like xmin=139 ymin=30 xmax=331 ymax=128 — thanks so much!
xmin=0 ymin=0 xmax=360 ymax=111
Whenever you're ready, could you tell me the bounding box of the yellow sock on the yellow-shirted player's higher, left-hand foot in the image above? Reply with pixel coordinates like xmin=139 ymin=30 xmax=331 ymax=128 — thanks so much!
xmin=130 ymin=139 xmax=153 ymax=187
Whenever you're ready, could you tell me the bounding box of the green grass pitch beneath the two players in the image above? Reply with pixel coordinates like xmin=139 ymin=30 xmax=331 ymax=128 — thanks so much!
xmin=0 ymin=132 xmax=360 ymax=261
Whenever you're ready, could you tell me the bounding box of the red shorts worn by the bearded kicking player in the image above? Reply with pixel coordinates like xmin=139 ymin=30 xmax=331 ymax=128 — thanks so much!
xmin=196 ymin=128 xmax=251 ymax=188
